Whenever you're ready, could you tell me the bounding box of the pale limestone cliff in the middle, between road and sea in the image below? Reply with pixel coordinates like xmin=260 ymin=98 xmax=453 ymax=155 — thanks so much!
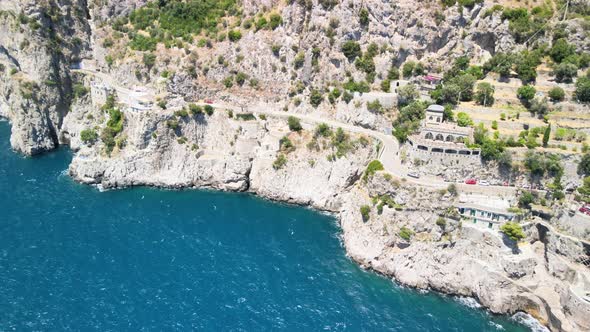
xmin=64 ymin=100 xmax=374 ymax=211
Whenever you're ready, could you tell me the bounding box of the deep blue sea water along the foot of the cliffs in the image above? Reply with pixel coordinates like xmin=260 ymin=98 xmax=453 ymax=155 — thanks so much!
xmin=0 ymin=122 xmax=527 ymax=331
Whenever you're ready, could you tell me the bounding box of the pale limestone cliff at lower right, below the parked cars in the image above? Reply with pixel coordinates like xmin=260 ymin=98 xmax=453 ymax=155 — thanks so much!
xmin=340 ymin=175 xmax=590 ymax=331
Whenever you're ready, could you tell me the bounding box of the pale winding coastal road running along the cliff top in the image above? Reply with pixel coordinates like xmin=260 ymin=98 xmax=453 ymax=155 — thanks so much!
xmin=73 ymin=68 xmax=517 ymax=197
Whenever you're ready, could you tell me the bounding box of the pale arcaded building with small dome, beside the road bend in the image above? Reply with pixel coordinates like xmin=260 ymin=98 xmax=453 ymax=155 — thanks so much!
xmin=408 ymin=105 xmax=481 ymax=164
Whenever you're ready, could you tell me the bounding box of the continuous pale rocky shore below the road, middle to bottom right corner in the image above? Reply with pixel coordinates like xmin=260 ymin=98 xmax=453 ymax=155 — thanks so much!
xmin=55 ymin=102 xmax=590 ymax=331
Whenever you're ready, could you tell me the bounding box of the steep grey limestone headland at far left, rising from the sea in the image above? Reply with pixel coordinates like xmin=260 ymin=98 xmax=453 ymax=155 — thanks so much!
xmin=0 ymin=0 xmax=90 ymax=155
